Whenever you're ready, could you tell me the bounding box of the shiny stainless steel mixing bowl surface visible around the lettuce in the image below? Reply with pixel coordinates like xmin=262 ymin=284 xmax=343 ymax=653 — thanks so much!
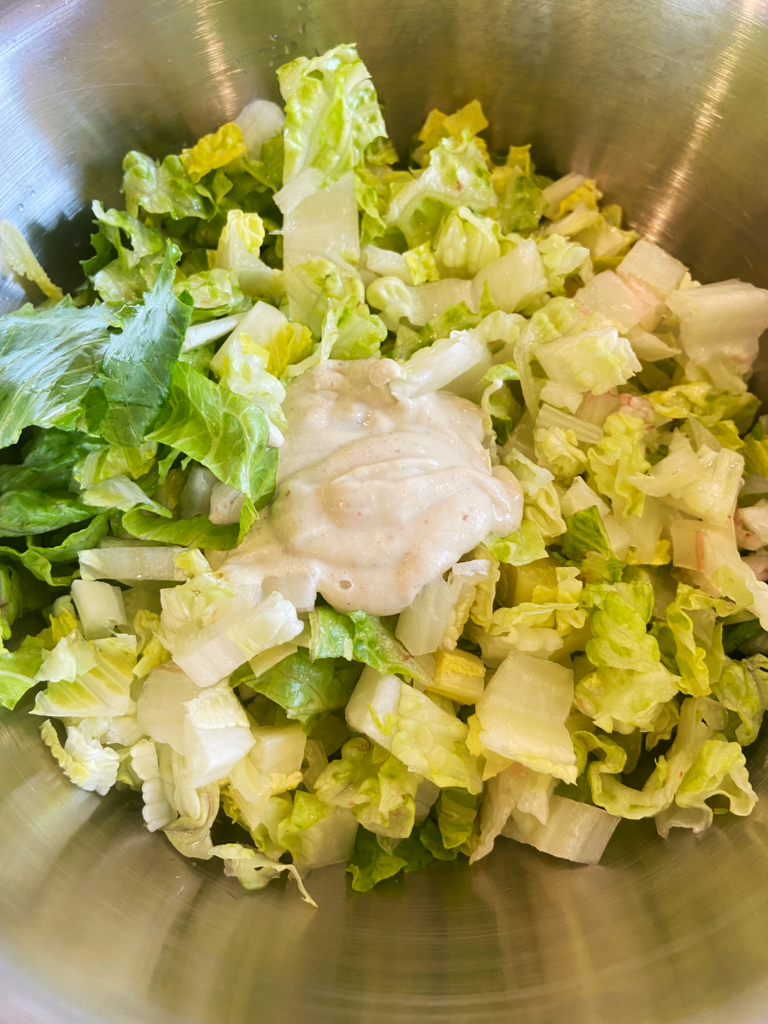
xmin=0 ymin=0 xmax=768 ymax=1024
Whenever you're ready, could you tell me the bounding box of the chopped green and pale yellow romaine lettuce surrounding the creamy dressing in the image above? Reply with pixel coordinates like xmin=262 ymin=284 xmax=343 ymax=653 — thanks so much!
xmin=0 ymin=45 xmax=768 ymax=902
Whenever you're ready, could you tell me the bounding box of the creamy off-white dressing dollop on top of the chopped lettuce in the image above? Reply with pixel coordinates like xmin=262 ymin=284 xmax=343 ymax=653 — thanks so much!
xmin=221 ymin=359 xmax=522 ymax=615
